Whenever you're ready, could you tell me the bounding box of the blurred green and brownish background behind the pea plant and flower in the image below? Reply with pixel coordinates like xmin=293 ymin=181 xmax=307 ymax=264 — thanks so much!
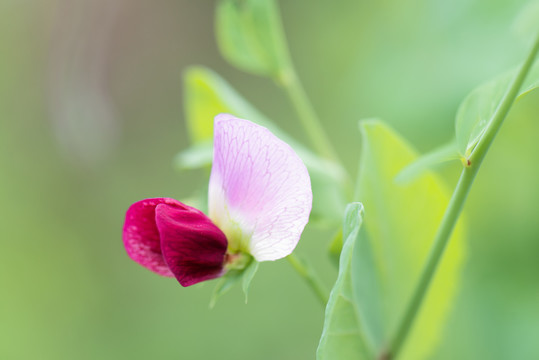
xmin=0 ymin=0 xmax=539 ymax=360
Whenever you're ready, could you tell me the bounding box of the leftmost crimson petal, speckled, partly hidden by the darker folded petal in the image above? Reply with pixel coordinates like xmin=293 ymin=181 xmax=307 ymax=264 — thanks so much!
xmin=123 ymin=198 xmax=180 ymax=276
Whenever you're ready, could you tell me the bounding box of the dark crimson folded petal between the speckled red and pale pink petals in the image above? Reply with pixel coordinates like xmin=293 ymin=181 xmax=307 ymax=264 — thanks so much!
xmin=155 ymin=204 xmax=228 ymax=286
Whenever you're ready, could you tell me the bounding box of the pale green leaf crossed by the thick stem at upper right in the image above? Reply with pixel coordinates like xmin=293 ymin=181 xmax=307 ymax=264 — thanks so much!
xmin=456 ymin=63 xmax=539 ymax=158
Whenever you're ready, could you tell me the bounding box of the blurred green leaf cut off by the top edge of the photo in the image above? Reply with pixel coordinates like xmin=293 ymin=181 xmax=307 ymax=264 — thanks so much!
xmin=216 ymin=0 xmax=290 ymax=79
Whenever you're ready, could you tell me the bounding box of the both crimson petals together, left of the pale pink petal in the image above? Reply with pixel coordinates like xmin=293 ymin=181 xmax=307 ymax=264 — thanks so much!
xmin=123 ymin=198 xmax=227 ymax=286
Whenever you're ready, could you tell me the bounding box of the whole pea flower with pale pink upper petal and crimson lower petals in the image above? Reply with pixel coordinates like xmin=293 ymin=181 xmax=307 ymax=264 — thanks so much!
xmin=123 ymin=114 xmax=312 ymax=286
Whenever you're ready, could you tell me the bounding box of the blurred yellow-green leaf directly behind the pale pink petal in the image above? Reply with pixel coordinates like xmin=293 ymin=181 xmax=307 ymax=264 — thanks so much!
xmin=184 ymin=67 xmax=346 ymax=226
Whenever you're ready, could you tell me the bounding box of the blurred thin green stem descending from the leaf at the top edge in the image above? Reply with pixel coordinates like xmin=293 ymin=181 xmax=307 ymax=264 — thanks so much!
xmin=280 ymin=65 xmax=339 ymax=163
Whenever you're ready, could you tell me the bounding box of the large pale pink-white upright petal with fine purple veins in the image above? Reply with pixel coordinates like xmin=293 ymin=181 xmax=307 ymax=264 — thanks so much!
xmin=209 ymin=114 xmax=312 ymax=261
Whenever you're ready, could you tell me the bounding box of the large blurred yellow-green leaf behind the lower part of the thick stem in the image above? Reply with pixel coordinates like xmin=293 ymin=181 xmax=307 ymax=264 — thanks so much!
xmin=356 ymin=121 xmax=464 ymax=360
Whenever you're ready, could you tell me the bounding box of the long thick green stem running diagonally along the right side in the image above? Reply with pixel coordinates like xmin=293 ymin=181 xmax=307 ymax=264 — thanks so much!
xmin=379 ymin=32 xmax=539 ymax=360
